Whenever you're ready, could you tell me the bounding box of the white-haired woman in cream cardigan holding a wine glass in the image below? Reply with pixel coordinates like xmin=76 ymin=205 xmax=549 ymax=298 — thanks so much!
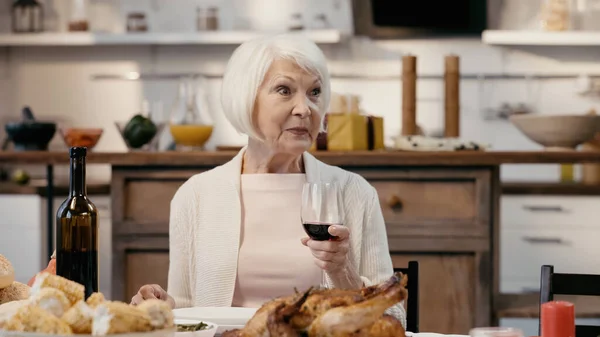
xmin=132 ymin=35 xmax=406 ymax=325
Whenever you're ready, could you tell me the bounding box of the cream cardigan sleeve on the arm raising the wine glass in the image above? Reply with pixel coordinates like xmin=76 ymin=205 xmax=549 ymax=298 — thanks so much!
xmin=360 ymin=186 xmax=406 ymax=329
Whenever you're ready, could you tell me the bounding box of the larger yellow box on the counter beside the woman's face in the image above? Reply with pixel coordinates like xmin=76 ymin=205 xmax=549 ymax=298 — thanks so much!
xmin=327 ymin=113 xmax=369 ymax=151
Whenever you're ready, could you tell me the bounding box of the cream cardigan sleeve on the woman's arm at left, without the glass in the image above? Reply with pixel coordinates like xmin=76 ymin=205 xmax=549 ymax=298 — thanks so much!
xmin=167 ymin=193 xmax=192 ymax=308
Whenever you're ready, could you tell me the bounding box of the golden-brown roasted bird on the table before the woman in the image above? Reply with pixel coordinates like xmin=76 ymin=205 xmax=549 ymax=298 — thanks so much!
xmin=223 ymin=273 xmax=407 ymax=337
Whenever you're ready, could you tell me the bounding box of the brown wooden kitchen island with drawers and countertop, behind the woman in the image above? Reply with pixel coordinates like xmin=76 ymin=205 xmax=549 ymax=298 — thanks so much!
xmin=0 ymin=151 xmax=600 ymax=334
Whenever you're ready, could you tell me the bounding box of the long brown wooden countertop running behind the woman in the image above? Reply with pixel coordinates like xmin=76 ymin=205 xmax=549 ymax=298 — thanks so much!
xmin=0 ymin=151 xmax=600 ymax=167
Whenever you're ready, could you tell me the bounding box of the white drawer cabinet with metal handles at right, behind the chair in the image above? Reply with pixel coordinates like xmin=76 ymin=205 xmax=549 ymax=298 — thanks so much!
xmin=500 ymin=195 xmax=600 ymax=294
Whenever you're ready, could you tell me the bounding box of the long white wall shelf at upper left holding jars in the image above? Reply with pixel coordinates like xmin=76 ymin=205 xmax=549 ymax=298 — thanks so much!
xmin=0 ymin=29 xmax=342 ymax=47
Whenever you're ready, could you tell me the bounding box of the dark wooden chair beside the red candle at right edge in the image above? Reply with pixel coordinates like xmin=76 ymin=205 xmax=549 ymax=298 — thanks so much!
xmin=538 ymin=265 xmax=600 ymax=337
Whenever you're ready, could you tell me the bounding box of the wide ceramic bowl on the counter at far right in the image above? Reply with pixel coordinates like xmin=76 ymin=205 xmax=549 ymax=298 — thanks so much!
xmin=510 ymin=115 xmax=600 ymax=151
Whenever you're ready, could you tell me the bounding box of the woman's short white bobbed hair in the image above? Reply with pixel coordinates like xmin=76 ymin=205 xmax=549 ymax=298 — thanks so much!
xmin=221 ymin=34 xmax=331 ymax=139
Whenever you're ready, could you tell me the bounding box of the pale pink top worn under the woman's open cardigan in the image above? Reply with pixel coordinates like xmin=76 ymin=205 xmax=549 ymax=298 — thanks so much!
xmin=232 ymin=174 xmax=321 ymax=308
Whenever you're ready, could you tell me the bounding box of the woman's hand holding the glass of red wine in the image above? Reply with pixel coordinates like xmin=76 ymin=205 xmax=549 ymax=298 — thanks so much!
xmin=302 ymin=225 xmax=350 ymax=275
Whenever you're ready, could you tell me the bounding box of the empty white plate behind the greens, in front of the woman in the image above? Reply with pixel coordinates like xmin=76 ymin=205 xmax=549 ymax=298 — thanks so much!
xmin=173 ymin=307 xmax=258 ymax=334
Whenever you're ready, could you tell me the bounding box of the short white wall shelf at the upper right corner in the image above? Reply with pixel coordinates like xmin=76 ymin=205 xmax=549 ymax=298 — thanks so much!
xmin=482 ymin=30 xmax=600 ymax=46
